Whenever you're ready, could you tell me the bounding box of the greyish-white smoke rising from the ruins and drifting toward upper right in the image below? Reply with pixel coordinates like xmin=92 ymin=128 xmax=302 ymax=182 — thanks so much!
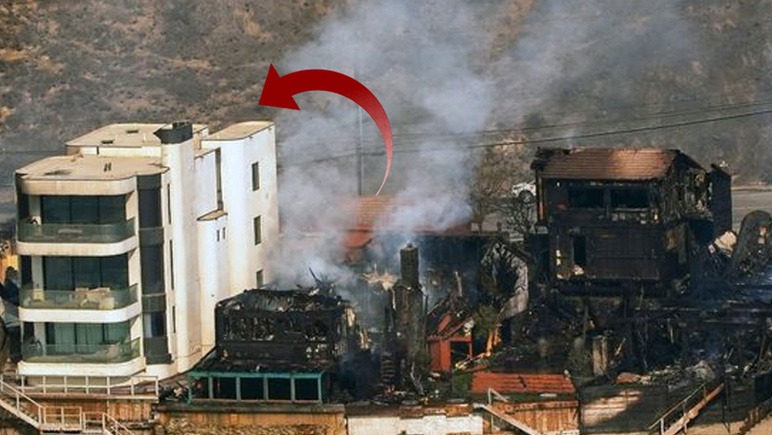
xmin=274 ymin=0 xmax=699 ymax=282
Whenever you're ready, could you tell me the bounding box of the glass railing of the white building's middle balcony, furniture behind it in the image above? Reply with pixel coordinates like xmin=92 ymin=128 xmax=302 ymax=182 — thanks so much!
xmin=19 ymin=284 xmax=138 ymax=310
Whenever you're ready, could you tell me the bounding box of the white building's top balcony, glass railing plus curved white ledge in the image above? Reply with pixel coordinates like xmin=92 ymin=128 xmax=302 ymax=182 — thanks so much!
xmin=17 ymin=218 xmax=138 ymax=256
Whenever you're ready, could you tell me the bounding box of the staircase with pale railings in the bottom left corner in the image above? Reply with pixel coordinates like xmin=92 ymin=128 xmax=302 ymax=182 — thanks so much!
xmin=0 ymin=379 xmax=133 ymax=435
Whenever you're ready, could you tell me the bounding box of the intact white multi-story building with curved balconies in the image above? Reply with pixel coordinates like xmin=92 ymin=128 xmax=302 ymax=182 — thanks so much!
xmin=16 ymin=122 xmax=279 ymax=377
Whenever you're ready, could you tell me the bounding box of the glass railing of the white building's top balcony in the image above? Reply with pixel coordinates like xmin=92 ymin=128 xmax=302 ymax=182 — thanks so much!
xmin=18 ymin=218 xmax=134 ymax=243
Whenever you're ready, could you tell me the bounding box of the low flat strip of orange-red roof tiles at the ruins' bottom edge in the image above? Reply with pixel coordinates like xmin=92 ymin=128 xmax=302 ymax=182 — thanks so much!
xmin=472 ymin=372 xmax=576 ymax=394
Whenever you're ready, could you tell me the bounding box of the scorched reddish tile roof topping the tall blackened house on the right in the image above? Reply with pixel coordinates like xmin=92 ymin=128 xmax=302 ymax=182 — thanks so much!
xmin=541 ymin=148 xmax=684 ymax=181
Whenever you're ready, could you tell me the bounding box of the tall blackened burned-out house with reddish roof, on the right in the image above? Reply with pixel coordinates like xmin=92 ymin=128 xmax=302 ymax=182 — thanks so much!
xmin=531 ymin=148 xmax=731 ymax=295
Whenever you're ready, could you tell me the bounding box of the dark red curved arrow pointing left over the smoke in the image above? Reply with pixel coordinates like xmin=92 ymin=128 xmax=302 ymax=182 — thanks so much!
xmin=258 ymin=64 xmax=394 ymax=195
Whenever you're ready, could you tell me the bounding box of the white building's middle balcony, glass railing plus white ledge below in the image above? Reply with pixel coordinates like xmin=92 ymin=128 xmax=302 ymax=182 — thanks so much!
xmin=19 ymin=284 xmax=142 ymax=323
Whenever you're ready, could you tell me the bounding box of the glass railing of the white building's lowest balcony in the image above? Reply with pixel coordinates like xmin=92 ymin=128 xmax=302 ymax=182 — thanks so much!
xmin=21 ymin=338 xmax=140 ymax=364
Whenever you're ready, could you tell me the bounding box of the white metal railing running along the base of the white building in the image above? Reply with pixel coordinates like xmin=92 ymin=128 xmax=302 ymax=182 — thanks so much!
xmin=0 ymin=375 xmax=159 ymax=399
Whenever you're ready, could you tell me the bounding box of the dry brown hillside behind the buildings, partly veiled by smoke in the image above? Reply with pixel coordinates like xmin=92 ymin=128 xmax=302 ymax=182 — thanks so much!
xmin=0 ymin=0 xmax=772 ymax=198
